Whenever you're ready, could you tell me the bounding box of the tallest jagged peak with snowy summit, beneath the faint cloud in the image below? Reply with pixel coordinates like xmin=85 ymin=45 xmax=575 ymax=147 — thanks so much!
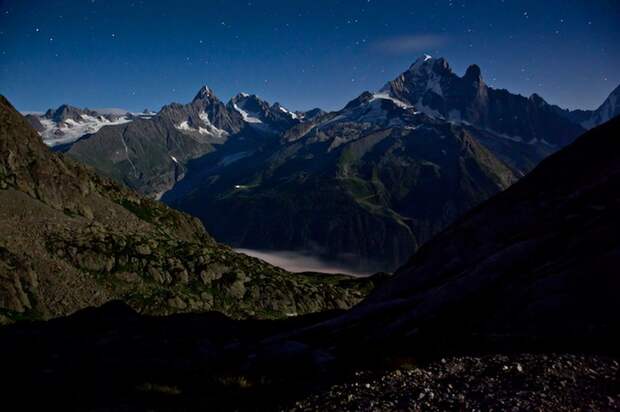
xmin=380 ymin=55 xmax=583 ymax=147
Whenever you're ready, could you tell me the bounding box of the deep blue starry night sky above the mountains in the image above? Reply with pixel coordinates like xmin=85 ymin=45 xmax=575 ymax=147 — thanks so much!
xmin=0 ymin=0 xmax=620 ymax=111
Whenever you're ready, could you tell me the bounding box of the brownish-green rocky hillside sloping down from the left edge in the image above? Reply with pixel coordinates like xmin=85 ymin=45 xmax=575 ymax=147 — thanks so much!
xmin=0 ymin=97 xmax=380 ymax=323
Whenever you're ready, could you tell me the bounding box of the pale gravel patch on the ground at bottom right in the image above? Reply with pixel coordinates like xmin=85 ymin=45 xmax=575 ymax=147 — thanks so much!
xmin=288 ymin=354 xmax=620 ymax=411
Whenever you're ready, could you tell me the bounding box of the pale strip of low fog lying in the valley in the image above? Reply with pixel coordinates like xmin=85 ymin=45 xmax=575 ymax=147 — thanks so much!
xmin=235 ymin=249 xmax=376 ymax=276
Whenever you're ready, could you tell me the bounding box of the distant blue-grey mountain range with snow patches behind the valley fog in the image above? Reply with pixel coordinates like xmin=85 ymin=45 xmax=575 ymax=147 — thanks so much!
xmin=24 ymin=56 xmax=620 ymax=270
